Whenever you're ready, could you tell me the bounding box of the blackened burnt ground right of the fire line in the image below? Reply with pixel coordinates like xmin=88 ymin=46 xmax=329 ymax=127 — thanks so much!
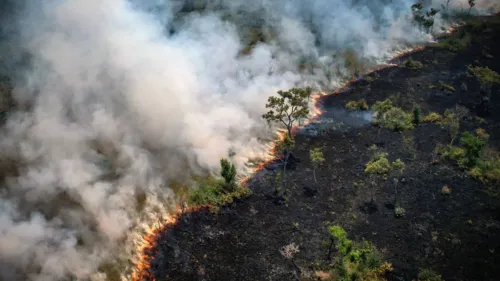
xmin=146 ymin=15 xmax=500 ymax=281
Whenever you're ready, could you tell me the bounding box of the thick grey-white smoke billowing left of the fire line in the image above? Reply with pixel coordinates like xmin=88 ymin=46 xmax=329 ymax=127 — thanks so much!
xmin=0 ymin=0 xmax=496 ymax=281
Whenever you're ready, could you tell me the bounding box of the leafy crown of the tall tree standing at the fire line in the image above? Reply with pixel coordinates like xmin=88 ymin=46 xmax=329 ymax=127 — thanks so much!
xmin=262 ymin=88 xmax=311 ymax=138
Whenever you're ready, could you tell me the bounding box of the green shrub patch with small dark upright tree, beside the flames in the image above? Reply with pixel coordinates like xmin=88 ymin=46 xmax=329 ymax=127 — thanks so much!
xmin=189 ymin=159 xmax=250 ymax=211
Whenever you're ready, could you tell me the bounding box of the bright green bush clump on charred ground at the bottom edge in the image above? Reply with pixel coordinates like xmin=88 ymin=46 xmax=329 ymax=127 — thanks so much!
xmin=328 ymin=225 xmax=392 ymax=281
